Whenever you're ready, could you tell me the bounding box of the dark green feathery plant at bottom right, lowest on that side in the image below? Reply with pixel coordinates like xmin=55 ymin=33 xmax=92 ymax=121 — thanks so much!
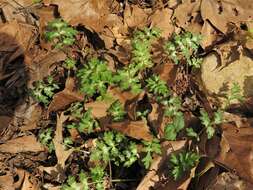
xmin=169 ymin=152 xmax=200 ymax=180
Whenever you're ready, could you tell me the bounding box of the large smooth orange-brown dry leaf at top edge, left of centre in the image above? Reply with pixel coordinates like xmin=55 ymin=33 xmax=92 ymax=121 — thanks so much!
xmin=51 ymin=0 xmax=110 ymax=32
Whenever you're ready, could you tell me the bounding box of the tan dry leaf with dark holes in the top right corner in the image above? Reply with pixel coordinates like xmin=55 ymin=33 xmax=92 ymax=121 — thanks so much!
xmin=201 ymin=0 xmax=253 ymax=33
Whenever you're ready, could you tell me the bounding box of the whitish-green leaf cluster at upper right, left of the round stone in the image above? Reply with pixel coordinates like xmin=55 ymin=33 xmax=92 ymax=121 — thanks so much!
xmin=164 ymin=32 xmax=202 ymax=68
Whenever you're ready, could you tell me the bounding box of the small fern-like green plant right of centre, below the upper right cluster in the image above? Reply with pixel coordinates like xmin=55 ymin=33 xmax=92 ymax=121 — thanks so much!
xmin=146 ymin=75 xmax=170 ymax=101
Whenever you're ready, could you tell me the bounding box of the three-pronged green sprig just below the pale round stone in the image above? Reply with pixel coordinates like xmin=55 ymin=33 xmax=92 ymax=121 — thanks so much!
xmin=200 ymin=110 xmax=223 ymax=139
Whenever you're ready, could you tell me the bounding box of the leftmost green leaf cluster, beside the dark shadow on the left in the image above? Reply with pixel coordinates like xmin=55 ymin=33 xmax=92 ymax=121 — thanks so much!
xmin=31 ymin=76 xmax=59 ymax=105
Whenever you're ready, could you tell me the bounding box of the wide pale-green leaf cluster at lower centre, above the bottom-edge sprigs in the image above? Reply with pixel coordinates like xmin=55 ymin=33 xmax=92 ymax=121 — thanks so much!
xmin=90 ymin=131 xmax=138 ymax=167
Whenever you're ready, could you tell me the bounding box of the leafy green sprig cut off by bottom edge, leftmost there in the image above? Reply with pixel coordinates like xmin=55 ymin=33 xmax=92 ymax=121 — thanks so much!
xmin=61 ymin=172 xmax=90 ymax=190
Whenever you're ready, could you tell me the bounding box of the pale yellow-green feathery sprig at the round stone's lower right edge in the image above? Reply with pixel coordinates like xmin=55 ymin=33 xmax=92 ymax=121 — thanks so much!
xmin=225 ymin=82 xmax=244 ymax=108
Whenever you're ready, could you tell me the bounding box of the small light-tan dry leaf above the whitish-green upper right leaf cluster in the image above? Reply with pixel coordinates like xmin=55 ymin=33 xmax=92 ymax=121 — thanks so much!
xmin=149 ymin=8 xmax=174 ymax=39
